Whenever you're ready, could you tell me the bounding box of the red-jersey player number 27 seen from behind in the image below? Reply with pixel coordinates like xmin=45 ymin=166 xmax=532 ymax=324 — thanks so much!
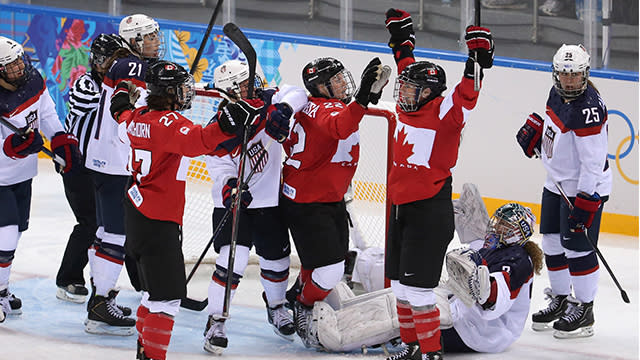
xmin=110 ymin=60 xmax=262 ymax=360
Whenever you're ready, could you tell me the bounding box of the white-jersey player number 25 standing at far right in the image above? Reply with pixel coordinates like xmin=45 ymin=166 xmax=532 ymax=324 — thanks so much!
xmin=516 ymin=45 xmax=612 ymax=338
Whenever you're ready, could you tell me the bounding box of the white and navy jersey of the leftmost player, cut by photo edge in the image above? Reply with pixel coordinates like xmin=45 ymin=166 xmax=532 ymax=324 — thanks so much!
xmin=0 ymin=67 xmax=64 ymax=186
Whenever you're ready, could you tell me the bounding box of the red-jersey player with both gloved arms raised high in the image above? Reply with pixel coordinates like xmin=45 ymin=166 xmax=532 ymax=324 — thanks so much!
xmin=385 ymin=9 xmax=494 ymax=360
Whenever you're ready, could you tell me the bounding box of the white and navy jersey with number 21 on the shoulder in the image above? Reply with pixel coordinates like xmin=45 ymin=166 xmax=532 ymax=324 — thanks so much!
xmin=85 ymin=55 xmax=147 ymax=175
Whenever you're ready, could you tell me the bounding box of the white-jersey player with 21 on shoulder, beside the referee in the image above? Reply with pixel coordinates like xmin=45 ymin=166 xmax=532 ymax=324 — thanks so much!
xmin=85 ymin=14 xmax=164 ymax=335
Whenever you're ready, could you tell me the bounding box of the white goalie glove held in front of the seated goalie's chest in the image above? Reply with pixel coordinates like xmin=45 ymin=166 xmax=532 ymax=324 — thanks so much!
xmin=446 ymin=248 xmax=491 ymax=307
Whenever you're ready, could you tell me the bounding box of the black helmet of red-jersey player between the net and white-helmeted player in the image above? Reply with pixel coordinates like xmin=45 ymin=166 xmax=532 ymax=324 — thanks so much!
xmin=302 ymin=57 xmax=355 ymax=104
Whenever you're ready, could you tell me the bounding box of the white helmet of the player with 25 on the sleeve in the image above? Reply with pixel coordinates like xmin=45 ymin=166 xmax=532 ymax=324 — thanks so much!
xmin=552 ymin=44 xmax=591 ymax=99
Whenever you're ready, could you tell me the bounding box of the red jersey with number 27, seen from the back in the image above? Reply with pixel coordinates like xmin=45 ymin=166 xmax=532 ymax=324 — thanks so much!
xmin=121 ymin=106 xmax=233 ymax=224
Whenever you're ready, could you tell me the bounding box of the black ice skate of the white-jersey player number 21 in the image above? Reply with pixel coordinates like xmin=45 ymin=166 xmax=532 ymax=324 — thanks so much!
xmin=84 ymin=290 xmax=136 ymax=336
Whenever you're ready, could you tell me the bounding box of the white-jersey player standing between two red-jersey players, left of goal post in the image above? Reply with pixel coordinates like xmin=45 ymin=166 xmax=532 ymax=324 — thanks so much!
xmin=204 ymin=60 xmax=307 ymax=354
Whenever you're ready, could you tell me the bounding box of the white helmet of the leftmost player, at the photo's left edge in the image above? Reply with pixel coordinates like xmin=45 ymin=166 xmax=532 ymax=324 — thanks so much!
xmin=0 ymin=36 xmax=32 ymax=87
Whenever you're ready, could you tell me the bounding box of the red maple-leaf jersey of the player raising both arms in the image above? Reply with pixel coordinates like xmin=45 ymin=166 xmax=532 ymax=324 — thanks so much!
xmin=388 ymin=77 xmax=478 ymax=204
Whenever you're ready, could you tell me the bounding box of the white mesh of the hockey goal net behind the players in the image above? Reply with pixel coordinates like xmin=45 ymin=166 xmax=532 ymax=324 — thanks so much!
xmin=182 ymin=90 xmax=395 ymax=266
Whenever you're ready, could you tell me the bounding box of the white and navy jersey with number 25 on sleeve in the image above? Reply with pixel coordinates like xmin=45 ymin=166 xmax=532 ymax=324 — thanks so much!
xmin=541 ymin=85 xmax=612 ymax=197
